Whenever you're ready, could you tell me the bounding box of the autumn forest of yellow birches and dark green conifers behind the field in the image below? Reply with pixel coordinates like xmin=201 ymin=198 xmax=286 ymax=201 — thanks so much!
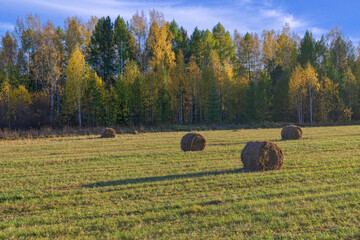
xmin=0 ymin=9 xmax=360 ymax=129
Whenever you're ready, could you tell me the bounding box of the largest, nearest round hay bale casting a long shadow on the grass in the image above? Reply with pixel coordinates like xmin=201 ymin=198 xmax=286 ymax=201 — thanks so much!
xmin=241 ymin=141 xmax=284 ymax=171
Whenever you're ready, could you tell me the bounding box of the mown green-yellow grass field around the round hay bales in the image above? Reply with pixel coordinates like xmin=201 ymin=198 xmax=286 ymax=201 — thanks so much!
xmin=0 ymin=126 xmax=360 ymax=239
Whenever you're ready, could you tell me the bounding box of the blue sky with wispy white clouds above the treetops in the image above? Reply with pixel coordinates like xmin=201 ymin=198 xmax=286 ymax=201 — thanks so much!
xmin=0 ymin=0 xmax=360 ymax=46
